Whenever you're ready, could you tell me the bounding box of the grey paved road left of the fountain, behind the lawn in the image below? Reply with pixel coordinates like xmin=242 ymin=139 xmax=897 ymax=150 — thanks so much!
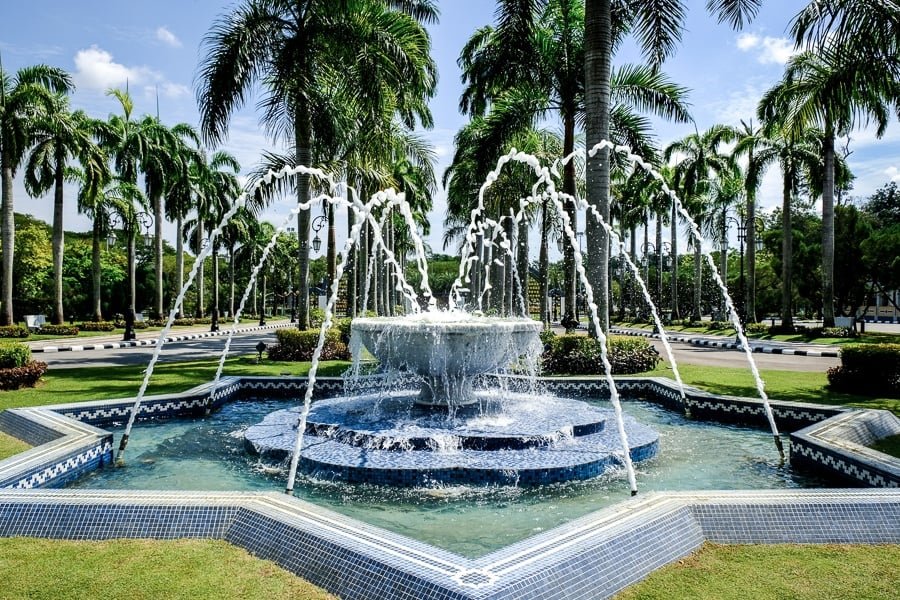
xmin=34 ymin=330 xmax=276 ymax=369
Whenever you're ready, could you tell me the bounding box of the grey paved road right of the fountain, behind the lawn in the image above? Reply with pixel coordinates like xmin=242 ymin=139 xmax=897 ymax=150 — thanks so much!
xmin=650 ymin=340 xmax=841 ymax=373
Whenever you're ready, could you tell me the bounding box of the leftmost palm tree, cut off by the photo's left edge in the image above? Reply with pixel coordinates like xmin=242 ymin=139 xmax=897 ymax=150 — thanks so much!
xmin=0 ymin=65 xmax=73 ymax=325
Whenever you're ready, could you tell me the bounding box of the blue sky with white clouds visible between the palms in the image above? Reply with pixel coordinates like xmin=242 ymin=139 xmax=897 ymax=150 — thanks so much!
xmin=0 ymin=0 xmax=900 ymax=252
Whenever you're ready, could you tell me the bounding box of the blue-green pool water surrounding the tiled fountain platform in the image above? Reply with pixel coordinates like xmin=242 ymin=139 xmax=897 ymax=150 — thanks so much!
xmin=71 ymin=400 xmax=825 ymax=557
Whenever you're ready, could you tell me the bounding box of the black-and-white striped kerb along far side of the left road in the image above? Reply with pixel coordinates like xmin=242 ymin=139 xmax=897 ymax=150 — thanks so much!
xmin=25 ymin=319 xmax=296 ymax=353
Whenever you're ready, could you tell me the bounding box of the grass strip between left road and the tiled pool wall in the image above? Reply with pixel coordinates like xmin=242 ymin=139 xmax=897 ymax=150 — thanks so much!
xmin=0 ymin=354 xmax=350 ymax=410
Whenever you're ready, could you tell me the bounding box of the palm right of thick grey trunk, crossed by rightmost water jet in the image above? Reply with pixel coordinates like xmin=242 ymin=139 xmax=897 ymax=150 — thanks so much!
xmin=663 ymin=125 xmax=736 ymax=321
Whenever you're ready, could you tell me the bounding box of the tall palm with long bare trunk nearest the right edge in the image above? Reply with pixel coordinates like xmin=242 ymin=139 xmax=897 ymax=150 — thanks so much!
xmin=762 ymin=45 xmax=900 ymax=327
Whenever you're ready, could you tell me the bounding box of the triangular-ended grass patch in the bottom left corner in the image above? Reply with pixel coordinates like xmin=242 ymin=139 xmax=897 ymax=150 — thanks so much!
xmin=0 ymin=538 xmax=334 ymax=600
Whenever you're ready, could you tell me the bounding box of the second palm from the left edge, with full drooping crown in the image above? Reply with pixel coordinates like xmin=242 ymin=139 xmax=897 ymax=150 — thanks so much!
xmin=25 ymin=94 xmax=108 ymax=325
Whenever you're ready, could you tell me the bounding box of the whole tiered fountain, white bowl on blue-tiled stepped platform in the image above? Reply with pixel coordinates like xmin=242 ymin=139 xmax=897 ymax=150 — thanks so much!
xmin=245 ymin=312 xmax=658 ymax=486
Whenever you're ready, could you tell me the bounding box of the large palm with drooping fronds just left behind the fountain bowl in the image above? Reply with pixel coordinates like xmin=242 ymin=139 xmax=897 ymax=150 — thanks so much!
xmin=197 ymin=0 xmax=437 ymax=328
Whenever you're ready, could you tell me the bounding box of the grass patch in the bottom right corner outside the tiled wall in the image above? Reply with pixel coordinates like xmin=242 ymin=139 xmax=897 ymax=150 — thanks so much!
xmin=616 ymin=544 xmax=900 ymax=600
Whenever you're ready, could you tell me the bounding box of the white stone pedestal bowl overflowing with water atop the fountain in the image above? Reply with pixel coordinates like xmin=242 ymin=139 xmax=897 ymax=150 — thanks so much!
xmin=351 ymin=312 xmax=542 ymax=406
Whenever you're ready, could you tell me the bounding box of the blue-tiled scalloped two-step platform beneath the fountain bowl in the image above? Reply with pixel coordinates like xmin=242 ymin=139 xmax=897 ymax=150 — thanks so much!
xmin=245 ymin=391 xmax=659 ymax=486
